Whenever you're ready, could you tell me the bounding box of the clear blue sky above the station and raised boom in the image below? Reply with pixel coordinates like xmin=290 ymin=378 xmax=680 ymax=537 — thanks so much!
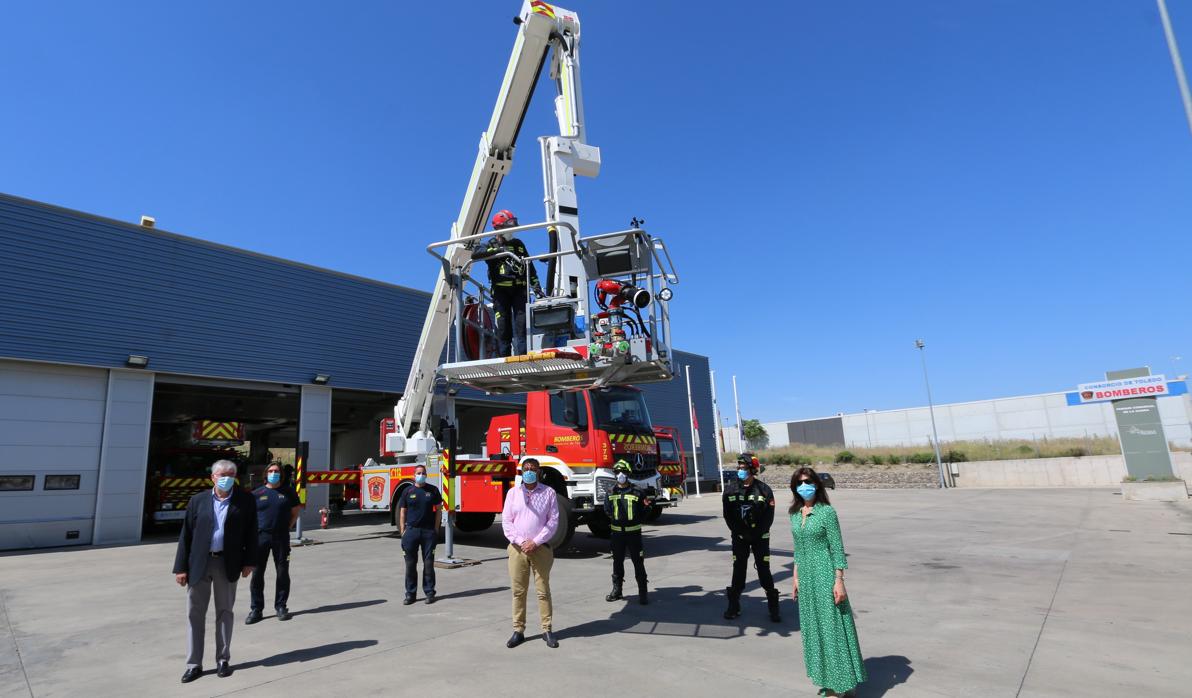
xmin=0 ymin=0 xmax=1192 ymax=420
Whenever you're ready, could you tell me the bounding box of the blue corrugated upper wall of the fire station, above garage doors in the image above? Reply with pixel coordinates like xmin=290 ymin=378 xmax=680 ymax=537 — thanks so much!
xmin=0 ymin=195 xmax=430 ymax=392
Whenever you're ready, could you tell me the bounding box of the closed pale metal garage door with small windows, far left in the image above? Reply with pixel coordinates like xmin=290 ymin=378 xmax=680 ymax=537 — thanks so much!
xmin=0 ymin=361 xmax=108 ymax=550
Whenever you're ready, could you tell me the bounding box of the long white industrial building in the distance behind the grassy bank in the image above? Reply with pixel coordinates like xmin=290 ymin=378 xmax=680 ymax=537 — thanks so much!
xmin=753 ymin=376 xmax=1192 ymax=450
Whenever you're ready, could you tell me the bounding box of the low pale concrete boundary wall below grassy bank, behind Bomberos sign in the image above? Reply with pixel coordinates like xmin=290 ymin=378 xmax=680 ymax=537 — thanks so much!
xmin=954 ymin=451 xmax=1192 ymax=487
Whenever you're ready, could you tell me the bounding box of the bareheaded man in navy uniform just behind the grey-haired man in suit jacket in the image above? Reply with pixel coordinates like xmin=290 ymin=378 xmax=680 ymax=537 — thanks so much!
xmin=244 ymin=463 xmax=302 ymax=625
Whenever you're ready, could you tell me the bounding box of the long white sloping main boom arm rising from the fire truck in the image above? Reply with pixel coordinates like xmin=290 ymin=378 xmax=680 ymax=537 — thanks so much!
xmin=386 ymin=0 xmax=581 ymax=451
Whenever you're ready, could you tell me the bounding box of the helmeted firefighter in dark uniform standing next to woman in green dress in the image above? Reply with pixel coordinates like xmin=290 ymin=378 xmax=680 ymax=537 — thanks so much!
xmin=722 ymin=453 xmax=782 ymax=623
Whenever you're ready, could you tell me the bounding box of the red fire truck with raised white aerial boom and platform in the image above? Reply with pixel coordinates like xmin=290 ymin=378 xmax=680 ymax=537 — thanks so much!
xmin=310 ymin=0 xmax=678 ymax=557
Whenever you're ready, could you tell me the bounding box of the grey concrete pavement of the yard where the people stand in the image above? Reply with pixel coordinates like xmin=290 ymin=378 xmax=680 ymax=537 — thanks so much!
xmin=0 ymin=488 xmax=1192 ymax=697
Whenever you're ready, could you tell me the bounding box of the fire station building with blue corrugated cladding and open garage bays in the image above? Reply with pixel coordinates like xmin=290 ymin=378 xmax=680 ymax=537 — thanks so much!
xmin=0 ymin=194 xmax=719 ymax=550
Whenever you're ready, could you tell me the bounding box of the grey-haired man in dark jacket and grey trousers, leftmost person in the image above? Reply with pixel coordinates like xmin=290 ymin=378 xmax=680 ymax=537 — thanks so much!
xmin=174 ymin=461 xmax=256 ymax=684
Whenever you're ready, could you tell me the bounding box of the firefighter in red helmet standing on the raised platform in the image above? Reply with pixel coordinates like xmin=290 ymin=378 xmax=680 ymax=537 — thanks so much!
xmin=472 ymin=210 xmax=546 ymax=356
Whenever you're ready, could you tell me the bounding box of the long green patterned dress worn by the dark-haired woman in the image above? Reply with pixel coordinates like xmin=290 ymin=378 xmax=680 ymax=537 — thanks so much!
xmin=790 ymin=504 xmax=868 ymax=693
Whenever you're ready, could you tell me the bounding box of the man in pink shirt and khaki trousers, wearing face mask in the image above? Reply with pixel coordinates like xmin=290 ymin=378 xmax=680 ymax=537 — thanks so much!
xmin=501 ymin=459 xmax=559 ymax=649
